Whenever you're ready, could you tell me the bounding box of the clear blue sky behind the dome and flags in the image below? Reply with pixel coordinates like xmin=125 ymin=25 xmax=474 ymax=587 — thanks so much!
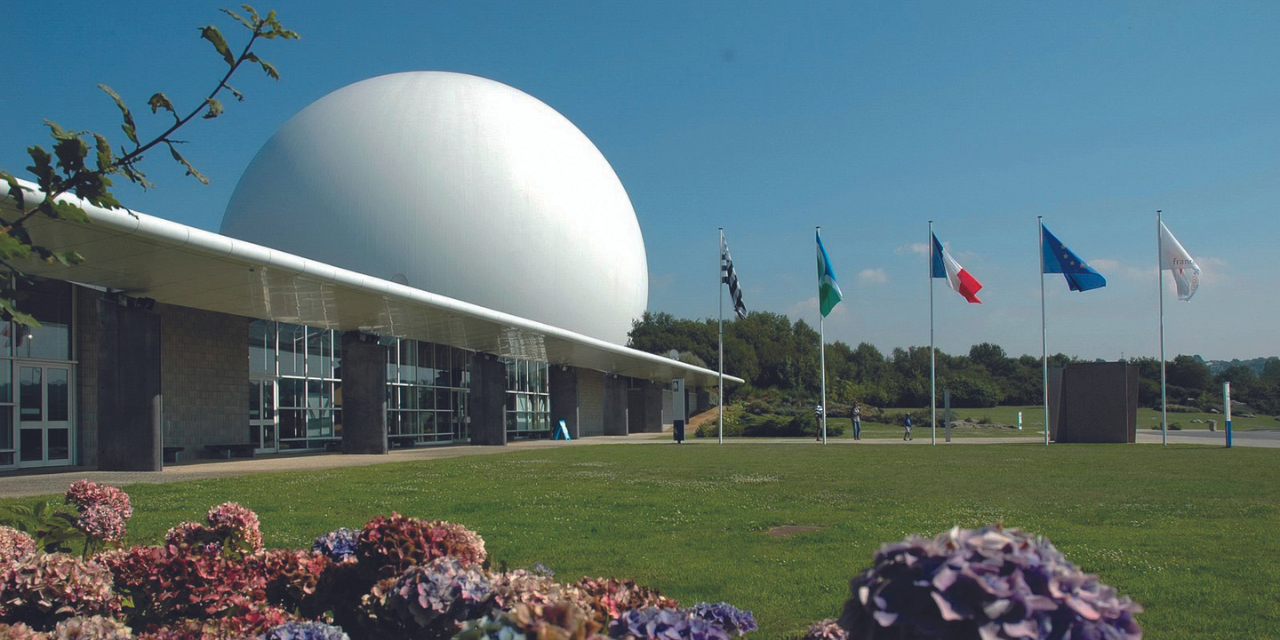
xmin=0 ymin=0 xmax=1280 ymax=360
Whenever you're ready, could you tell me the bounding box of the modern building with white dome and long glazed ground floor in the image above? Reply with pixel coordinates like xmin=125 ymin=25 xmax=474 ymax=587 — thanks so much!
xmin=0 ymin=72 xmax=741 ymax=471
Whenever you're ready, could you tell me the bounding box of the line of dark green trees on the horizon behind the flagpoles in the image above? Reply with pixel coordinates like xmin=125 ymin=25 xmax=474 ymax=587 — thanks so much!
xmin=630 ymin=311 xmax=1280 ymax=413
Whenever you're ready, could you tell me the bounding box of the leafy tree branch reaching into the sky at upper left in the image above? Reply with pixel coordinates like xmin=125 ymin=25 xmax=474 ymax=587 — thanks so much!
xmin=0 ymin=4 xmax=298 ymax=325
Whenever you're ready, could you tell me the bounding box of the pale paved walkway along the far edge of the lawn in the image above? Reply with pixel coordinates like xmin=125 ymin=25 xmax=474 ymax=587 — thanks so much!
xmin=0 ymin=430 xmax=1280 ymax=498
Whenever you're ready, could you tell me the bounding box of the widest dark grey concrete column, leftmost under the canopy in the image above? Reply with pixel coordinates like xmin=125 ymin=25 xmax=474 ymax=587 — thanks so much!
xmin=97 ymin=300 xmax=164 ymax=471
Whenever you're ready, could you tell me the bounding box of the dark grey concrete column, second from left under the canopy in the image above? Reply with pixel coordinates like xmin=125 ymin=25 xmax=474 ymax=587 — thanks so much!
xmin=342 ymin=332 xmax=387 ymax=453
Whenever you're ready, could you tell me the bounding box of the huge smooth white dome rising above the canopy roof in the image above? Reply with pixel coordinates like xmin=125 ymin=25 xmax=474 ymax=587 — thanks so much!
xmin=221 ymin=72 xmax=649 ymax=344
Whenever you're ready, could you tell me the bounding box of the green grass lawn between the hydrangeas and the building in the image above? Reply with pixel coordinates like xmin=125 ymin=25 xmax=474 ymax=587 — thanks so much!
xmin=4 ymin=443 xmax=1280 ymax=640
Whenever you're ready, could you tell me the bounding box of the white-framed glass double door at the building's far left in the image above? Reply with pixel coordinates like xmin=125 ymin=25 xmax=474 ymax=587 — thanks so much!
xmin=18 ymin=364 xmax=72 ymax=467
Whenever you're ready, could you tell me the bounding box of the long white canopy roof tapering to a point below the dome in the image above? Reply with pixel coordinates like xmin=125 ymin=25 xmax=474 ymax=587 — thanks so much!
xmin=0 ymin=180 xmax=742 ymax=387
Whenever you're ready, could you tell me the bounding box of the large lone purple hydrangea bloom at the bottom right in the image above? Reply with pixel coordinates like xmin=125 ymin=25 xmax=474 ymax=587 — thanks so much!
xmin=840 ymin=526 xmax=1142 ymax=640
